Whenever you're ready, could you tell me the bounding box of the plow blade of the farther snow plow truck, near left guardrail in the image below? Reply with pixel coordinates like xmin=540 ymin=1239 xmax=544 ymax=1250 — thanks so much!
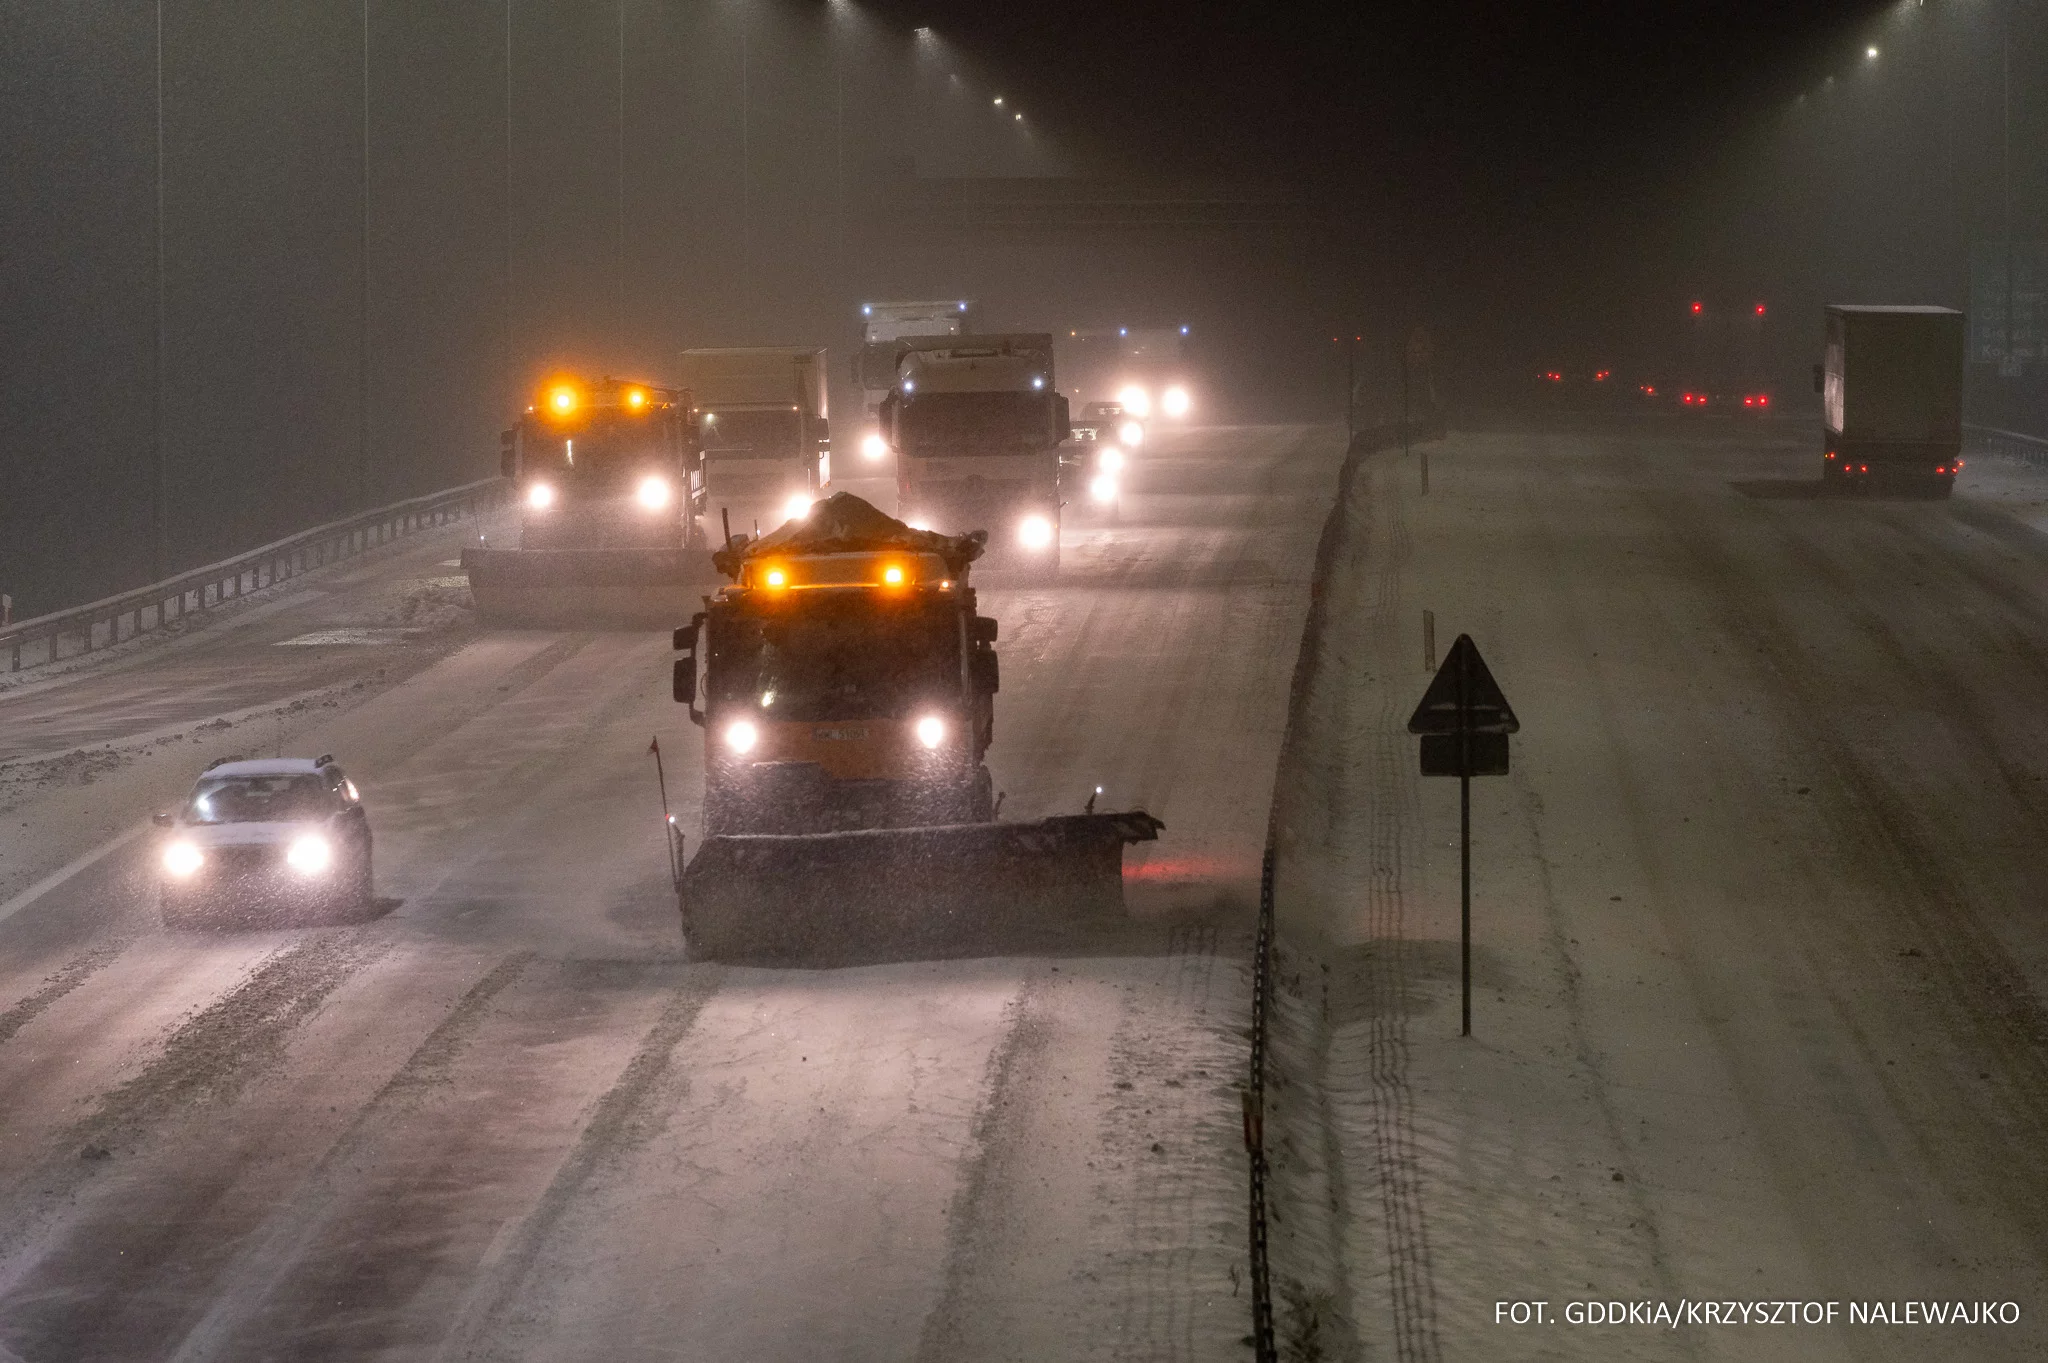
xmin=463 ymin=548 xmax=711 ymax=630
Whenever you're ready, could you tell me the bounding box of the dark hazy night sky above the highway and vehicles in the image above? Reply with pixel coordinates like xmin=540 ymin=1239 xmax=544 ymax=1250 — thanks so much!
xmin=0 ymin=0 xmax=2048 ymax=614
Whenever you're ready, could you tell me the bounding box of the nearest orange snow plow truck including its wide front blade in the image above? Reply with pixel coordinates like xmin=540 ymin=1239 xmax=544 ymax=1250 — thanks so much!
xmin=674 ymin=493 xmax=1163 ymax=960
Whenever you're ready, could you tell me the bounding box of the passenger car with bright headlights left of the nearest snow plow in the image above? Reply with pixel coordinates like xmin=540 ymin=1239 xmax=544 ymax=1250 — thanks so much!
xmin=156 ymin=755 xmax=371 ymax=927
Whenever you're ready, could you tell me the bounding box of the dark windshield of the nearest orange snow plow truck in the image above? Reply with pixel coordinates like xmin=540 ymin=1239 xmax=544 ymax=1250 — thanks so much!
xmin=713 ymin=591 xmax=961 ymax=722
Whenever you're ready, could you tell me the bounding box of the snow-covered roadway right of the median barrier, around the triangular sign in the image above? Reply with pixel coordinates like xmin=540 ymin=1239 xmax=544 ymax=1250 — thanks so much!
xmin=1268 ymin=422 xmax=2048 ymax=1361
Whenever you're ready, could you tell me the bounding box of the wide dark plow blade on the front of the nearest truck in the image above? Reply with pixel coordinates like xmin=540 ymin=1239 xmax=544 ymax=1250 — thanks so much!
xmin=682 ymin=810 xmax=1165 ymax=962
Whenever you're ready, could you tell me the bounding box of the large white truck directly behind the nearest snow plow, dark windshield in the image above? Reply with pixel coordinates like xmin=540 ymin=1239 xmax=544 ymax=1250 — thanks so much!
xmin=881 ymin=332 xmax=1073 ymax=577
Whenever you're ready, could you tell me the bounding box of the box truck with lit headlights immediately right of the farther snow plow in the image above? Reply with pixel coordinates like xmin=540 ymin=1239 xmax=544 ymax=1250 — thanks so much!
xmin=682 ymin=346 xmax=831 ymax=544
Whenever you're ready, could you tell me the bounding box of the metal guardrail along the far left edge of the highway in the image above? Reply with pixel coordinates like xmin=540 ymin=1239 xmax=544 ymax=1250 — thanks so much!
xmin=0 ymin=477 xmax=510 ymax=671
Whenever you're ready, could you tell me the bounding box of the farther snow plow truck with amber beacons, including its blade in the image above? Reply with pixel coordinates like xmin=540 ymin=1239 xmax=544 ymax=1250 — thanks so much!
xmin=463 ymin=379 xmax=707 ymax=628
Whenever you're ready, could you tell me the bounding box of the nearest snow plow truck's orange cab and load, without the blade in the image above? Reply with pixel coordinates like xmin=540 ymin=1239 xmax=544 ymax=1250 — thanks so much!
xmin=676 ymin=493 xmax=997 ymax=837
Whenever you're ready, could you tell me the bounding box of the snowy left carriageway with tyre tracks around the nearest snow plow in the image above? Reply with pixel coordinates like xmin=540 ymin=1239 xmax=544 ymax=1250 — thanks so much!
xmin=0 ymin=428 xmax=1341 ymax=1363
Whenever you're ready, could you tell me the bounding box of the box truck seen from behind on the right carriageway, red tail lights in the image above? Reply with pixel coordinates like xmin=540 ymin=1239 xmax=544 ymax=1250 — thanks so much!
xmin=1812 ymin=303 xmax=1964 ymax=497
